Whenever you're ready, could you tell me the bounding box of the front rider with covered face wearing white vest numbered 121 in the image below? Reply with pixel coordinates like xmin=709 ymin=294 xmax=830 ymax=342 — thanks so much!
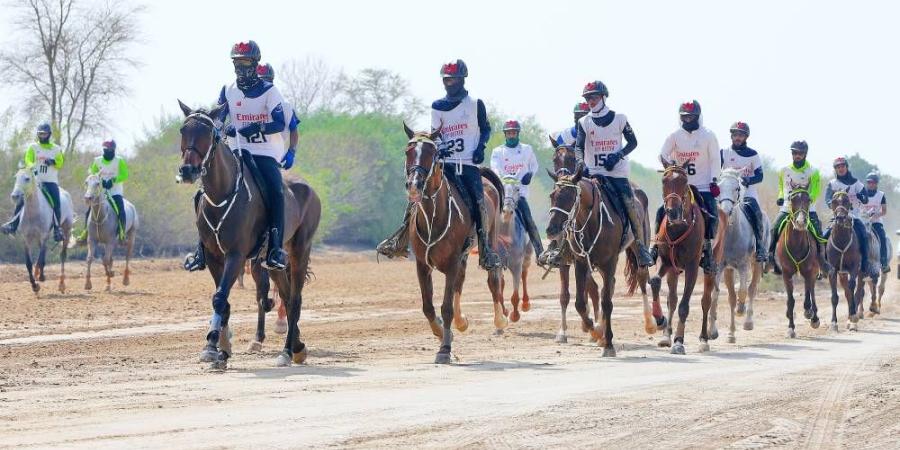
xmin=184 ymin=41 xmax=294 ymax=272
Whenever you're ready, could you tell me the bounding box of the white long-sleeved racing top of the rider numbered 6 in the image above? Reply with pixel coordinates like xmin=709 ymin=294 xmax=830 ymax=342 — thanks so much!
xmin=659 ymin=126 xmax=722 ymax=192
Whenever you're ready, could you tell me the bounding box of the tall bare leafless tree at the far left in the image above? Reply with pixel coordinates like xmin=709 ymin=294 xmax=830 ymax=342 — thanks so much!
xmin=0 ymin=0 xmax=143 ymax=153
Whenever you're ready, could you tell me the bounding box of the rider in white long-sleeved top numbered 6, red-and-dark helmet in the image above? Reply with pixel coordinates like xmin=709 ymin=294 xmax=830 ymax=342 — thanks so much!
xmin=653 ymin=100 xmax=722 ymax=273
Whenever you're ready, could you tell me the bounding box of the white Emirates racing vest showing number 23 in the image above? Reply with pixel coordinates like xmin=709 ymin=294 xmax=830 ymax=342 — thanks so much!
xmin=431 ymin=95 xmax=481 ymax=166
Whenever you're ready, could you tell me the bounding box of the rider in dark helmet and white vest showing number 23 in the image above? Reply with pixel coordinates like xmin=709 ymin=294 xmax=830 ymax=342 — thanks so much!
xmin=376 ymin=59 xmax=502 ymax=270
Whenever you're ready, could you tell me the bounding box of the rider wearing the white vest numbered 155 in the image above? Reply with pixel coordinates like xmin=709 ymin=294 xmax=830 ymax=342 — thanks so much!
xmin=575 ymin=80 xmax=653 ymax=267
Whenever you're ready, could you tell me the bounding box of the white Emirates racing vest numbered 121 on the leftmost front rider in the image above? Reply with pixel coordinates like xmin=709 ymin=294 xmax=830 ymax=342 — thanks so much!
xmin=225 ymin=84 xmax=288 ymax=161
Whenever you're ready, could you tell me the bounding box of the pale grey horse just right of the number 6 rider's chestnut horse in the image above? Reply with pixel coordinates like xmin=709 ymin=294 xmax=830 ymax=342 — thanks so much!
xmin=710 ymin=169 xmax=769 ymax=343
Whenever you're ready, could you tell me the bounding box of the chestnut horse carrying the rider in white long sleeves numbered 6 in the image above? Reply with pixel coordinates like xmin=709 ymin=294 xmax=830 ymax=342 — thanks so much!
xmin=650 ymin=161 xmax=722 ymax=355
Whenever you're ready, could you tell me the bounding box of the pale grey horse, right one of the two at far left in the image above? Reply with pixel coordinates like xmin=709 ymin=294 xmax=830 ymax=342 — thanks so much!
xmin=84 ymin=174 xmax=139 ymax=292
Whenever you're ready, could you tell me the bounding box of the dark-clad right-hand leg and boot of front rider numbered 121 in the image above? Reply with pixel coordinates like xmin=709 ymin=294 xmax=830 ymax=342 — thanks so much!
xmin=253 ymin=155 xmax=287 ymax=270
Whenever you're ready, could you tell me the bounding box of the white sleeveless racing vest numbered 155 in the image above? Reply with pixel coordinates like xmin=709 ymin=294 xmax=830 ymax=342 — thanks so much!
xmin=578 ymin=113 xmax=631 ymax=178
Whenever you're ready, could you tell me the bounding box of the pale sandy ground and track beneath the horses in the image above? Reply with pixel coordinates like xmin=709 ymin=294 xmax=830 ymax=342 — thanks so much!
xmin=0 ymin=251 xmax=900 ymax=449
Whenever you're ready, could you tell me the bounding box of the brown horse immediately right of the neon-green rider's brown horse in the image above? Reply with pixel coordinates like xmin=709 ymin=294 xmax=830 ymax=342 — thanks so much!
xmin=825 ymin=191 xmax=863 ymax=331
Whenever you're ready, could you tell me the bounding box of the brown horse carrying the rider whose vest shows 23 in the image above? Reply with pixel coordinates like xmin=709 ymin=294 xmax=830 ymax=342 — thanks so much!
xmin=403 ymin=123 xmax=509 ymax=364
